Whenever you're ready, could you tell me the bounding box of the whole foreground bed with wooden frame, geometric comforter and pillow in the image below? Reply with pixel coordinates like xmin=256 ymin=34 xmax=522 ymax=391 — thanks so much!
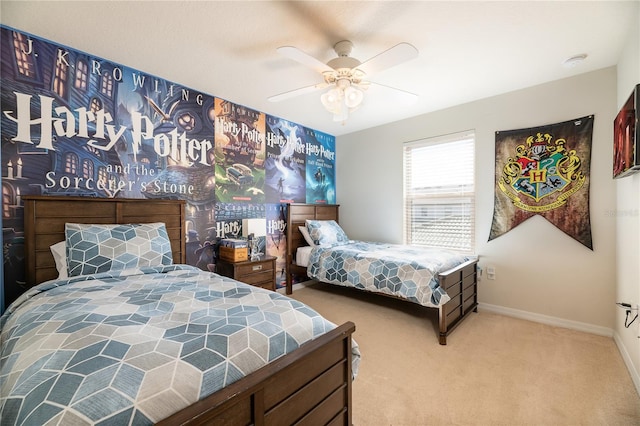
xmin=0 ymin=196 xmax=359 ymax=425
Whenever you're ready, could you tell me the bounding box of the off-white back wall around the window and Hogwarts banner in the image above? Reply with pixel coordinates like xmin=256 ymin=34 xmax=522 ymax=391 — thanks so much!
xmin=336 ymin=68 xmax=617 ymax=335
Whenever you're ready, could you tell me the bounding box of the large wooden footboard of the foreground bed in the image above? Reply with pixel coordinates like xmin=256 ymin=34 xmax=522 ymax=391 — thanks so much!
xmin=158 ymin=322 xmax=355 ymax=426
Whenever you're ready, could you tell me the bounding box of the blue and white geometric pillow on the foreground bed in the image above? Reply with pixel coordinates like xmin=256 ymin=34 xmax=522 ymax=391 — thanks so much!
xmin=65 ymin=222 xmax=173 ymax=277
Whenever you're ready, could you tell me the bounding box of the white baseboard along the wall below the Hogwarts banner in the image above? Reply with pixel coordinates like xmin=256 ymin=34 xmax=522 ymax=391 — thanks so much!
xmin=478 ymin=303 xmax=640 ymax=395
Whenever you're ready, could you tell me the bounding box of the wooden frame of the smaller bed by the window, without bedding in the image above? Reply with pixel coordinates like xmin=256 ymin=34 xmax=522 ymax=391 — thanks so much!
xmin=286 ymin=203 xmax=478 ymax=345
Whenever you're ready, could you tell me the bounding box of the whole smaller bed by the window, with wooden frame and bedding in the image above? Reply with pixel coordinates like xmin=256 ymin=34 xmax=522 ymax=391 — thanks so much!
xmin=286 ymin=204 xmax=478 ymax=345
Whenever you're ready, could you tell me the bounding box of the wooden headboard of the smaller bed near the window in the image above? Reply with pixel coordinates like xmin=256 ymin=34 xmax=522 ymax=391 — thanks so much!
xmin=286 ymin=203 xmax=340 ymax=294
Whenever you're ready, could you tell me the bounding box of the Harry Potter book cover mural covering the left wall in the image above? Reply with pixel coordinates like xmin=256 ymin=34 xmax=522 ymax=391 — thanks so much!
xmin=0 ymin=26 xmax=335 ymax=305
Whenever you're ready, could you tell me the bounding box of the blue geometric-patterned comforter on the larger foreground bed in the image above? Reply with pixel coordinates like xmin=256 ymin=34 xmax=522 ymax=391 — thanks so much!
xmin=0 ymin=265 xmax=359 ymax=425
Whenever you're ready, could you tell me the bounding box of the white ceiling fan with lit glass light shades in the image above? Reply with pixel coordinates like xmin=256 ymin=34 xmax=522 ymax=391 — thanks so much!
xmin=268 ymin=40 xmax=418 ymax=122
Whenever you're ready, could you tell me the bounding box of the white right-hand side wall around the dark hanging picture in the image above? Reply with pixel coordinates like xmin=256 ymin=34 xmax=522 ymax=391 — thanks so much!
xmin=615 ymin=6 xmax=640 ymax=393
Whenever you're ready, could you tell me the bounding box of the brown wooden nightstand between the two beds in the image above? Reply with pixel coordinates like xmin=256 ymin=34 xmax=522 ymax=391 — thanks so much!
xmin=216 ymin=256 xmax=276 ymax=291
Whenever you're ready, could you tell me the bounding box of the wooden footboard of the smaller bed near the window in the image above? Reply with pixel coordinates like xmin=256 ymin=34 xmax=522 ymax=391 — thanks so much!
xmin=439 ymin=260 xmax=478 ymax=345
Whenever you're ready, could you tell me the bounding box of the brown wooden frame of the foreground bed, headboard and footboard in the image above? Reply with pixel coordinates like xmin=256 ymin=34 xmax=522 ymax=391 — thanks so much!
xmin=23 ymin=196 xmax=355 ymax=426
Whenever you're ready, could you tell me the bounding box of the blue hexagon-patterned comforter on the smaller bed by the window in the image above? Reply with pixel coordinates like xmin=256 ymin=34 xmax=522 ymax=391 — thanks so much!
xmin=307 ymin=240 xmax=473 ymax=307
